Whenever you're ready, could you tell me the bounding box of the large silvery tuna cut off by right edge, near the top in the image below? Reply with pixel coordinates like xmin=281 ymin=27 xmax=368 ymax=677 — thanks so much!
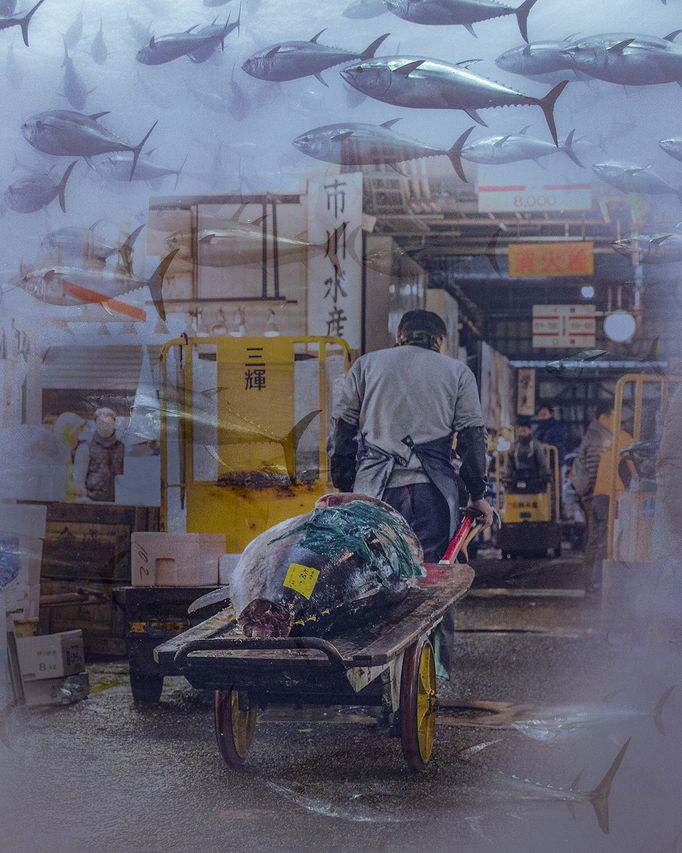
xmin=562 ymin=30 xmax=682 ymax=86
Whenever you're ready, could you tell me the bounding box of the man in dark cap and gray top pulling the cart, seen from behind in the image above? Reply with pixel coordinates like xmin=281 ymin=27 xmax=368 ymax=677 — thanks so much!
xmin=328 ymin=310 xmax=493 ymax=670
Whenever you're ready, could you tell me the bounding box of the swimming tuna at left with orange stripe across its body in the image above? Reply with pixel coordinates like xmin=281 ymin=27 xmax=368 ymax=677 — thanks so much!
xmin=13 ymin=252 xmax=176 ymax=321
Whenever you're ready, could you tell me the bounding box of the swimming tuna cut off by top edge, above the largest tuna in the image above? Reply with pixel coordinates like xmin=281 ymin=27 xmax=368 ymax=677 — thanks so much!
xmin=385 ymin=0 xmax=537 ymax=41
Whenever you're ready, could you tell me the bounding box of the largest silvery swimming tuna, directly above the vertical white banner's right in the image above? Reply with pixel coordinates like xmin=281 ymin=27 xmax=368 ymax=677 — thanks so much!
xmin=341 ymin=56 xmax=568 ymax=145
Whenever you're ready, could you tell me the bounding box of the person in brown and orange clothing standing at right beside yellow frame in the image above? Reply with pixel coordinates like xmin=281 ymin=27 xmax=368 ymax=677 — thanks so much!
xmin=569 ymin=400 xmax=633 ymax=593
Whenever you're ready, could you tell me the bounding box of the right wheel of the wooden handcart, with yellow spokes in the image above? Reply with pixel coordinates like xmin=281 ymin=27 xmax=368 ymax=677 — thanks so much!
xmin=400 ymin=637 xmax=437 ymax=770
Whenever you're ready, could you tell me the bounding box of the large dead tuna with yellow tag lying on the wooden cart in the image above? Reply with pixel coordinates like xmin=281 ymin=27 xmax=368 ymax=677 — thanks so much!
xmin=220 ymin=495 xmax=424 ymax=637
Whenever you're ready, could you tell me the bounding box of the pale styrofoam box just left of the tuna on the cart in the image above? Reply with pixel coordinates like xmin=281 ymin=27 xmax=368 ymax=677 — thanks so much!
xmin=130 ymin=533 xmax=225 ymax=586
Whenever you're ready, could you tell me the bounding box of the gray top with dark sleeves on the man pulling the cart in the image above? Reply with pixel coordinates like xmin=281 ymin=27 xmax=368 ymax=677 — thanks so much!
xmin=329 ymin=345 xmax=486 ymax=510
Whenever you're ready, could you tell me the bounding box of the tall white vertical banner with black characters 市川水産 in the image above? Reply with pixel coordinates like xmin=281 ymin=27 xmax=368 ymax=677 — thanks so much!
xmin=308 ymin=172 xmax=362 ymax=350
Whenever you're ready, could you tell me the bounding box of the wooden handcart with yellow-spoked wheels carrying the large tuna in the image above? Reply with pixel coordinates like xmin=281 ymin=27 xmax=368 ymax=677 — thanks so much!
xmin=154 ymin=563 xmax=474 ymax=770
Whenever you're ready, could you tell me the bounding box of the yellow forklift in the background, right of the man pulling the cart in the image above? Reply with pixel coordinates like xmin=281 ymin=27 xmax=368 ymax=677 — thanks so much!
xmin=495 ymin=444 xmax=561 ymax=560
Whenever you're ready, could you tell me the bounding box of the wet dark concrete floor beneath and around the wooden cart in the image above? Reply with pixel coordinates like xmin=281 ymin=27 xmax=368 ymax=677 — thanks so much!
xmin=0 ymin=559 xmax=682 ymax=853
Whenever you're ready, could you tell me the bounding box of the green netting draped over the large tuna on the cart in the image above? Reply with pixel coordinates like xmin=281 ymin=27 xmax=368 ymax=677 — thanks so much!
xmin=272 ymin=501 xmax=425 ymax=582
